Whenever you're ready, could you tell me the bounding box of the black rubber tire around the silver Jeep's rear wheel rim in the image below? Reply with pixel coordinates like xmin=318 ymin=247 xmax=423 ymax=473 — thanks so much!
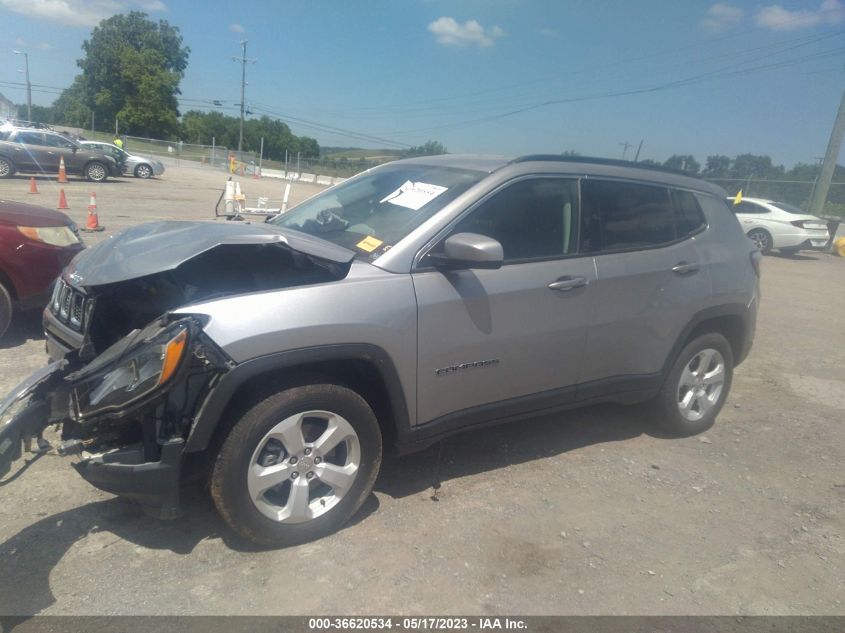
xmin=652 ymin=333 xmax=734 ymax=437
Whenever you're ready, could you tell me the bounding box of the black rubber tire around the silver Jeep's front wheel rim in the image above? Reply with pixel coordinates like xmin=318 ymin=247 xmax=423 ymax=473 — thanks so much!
xmin=211 ymin=384 xmax=382 ymax=546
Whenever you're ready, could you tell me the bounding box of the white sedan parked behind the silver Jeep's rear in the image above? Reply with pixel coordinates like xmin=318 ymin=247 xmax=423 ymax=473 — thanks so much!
xmin=728 ymin=197 xmax=830 ymax=254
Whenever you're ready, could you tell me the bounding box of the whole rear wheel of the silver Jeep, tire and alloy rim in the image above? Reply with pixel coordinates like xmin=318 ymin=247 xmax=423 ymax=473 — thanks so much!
xmin=654 ymin=333 xmax=734 ymax=437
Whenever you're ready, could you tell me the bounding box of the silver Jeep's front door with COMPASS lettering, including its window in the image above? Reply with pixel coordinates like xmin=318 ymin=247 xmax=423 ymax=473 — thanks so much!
xmin=413 ymin=177 xmax=595 ymax=423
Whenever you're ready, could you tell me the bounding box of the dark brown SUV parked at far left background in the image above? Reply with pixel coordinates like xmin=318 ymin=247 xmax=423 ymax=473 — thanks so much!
xmin=0 ymin=126 xmax=123 ymax=182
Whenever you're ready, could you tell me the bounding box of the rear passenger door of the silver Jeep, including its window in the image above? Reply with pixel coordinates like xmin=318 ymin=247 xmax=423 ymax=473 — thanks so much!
xmin=578 ymin=179 xmax=711 ymax=390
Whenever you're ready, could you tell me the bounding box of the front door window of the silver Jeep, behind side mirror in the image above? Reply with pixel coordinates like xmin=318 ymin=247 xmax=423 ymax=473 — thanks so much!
xmin=452 ymin=178 xmax=578 ymax=260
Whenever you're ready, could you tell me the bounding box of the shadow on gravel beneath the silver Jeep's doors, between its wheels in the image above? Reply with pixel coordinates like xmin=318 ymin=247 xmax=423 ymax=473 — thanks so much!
xmin=375 ymin=405 xmax=652 ymax=498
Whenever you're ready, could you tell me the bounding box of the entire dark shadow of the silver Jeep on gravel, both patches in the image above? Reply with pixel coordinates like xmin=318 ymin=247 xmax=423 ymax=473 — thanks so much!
xmin=0 ymin=405 xmax=656 ymax=616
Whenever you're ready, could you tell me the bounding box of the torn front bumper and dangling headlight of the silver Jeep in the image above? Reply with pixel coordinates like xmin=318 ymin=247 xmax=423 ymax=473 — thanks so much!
xmin=0 ymin=317 xmax=230 ymax=518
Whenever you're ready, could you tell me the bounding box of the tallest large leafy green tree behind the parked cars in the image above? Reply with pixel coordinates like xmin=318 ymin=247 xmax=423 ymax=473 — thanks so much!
xmin=77 ymin=11 xmax=190 ymax=137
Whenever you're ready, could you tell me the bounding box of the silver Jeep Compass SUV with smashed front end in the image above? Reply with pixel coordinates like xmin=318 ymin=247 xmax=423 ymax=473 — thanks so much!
xmin=0 ymin=155 xmax=760 ymax=544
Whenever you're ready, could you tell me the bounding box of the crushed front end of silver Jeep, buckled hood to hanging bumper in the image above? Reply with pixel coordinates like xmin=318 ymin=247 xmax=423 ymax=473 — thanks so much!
xmin=0 ymin=222 xmax=354 ymax=515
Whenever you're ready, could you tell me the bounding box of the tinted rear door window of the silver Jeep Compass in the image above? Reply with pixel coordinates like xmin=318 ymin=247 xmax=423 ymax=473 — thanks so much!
xmin=581 ymin=180 xmax=676 ymax=253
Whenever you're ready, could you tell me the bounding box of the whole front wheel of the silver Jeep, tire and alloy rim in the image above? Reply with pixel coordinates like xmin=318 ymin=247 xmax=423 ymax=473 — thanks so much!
xmin=211 ymin=384 xmax=382 ymax=546
